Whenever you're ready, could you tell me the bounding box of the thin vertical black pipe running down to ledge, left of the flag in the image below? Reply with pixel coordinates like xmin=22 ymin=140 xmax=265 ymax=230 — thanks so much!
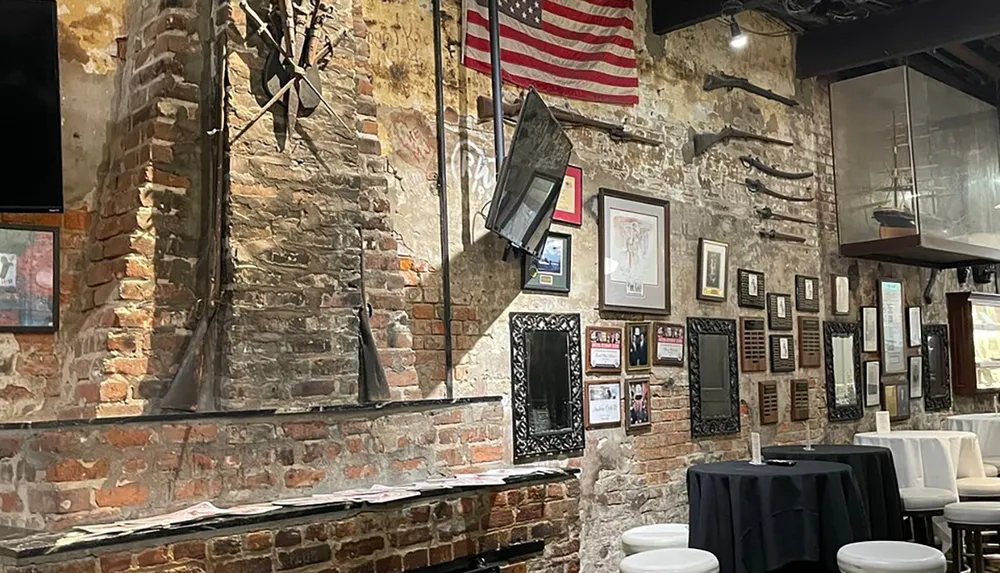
xmin=433 ymin=0 xmax=458 ymax=398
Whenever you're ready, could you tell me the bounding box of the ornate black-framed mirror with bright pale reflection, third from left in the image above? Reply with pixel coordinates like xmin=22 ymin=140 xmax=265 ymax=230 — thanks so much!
xmin=823 ymin=322 xmax=864 ymax=422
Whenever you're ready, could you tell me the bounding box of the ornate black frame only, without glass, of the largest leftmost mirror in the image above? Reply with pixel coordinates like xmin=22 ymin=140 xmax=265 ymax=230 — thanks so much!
xmin=510 ymin=312 xmax=584 ymax=461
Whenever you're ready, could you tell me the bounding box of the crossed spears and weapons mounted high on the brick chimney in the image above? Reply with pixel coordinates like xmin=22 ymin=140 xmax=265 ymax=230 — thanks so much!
xmin=229 ymin=0 xmax=350 ymax=145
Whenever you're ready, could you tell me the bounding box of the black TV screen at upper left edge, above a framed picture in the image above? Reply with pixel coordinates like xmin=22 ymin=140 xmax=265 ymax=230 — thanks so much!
xmin=0 ymin=0 xmax=63 ymax=213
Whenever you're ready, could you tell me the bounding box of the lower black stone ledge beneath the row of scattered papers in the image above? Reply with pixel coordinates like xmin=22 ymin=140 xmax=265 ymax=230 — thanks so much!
xmin=0 ymin=468 xmax=580 ymax=566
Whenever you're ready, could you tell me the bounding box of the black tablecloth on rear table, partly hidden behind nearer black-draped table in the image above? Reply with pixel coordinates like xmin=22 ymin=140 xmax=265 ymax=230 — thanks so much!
xmin=763 ymin=444 xmax=907 ymax=541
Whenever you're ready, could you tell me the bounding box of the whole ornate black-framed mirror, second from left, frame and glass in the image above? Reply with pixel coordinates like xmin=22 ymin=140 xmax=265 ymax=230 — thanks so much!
xmin=688 ymin=318 xmax=740 ymax=438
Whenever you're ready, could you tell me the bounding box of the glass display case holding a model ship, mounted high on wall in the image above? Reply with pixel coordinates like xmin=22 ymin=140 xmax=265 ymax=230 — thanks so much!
xmin=830 ymin=66 xmax=1000 ymax=268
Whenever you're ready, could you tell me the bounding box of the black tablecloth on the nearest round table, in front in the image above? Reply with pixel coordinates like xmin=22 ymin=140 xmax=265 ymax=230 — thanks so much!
xmin=687 ymin=461 xmax=871 ymax=573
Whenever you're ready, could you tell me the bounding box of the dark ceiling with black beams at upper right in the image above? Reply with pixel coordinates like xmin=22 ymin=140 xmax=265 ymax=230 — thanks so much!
xmin=651 ymin=0 xmax=1000 ymax=103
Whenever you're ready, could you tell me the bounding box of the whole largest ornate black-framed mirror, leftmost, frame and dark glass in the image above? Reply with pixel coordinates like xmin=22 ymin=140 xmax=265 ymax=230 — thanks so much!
xmin=510 ymin=313 xmax=584 ymax=461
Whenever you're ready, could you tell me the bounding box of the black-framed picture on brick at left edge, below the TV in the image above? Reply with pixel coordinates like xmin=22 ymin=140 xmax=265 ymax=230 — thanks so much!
xmin=0 ymin=225 xmax=59 ymax=332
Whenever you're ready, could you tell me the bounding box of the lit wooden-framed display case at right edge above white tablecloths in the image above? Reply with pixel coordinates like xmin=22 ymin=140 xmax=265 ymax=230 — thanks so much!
xmin=948 ymin=292 xmax=1000 ymax=394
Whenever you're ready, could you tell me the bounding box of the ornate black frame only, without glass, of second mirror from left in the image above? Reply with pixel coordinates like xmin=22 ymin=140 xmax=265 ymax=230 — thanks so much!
xmin=688 ymin=318 xmax=740 ymax=438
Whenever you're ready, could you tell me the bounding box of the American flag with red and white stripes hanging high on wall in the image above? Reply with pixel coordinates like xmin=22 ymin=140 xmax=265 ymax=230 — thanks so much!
xmin=463 ymin=0 xmax=639 ymax=105
